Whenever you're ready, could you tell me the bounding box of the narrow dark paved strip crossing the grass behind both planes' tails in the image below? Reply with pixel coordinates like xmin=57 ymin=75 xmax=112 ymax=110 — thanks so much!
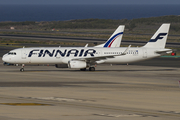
xmin=0 ymin=34 xmax=180 ymax=48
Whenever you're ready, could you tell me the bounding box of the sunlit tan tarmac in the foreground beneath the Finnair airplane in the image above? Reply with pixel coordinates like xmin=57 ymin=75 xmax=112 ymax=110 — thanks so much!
xmin=0 ymin=58 xmax=180 ymax=120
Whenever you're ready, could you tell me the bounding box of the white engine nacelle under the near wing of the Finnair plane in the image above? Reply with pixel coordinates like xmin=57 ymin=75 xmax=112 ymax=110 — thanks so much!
xmin=68 ymin=60 xmax=87 ymax=68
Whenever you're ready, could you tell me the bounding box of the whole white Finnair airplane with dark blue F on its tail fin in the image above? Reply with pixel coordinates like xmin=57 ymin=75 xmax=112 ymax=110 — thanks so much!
xmin=2 ymin=23 xmax=172 ymax=71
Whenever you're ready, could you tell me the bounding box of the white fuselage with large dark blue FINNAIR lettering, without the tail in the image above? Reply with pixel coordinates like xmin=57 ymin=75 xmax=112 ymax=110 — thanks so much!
xmin=2 ymin=47 xmax=161 ymax=64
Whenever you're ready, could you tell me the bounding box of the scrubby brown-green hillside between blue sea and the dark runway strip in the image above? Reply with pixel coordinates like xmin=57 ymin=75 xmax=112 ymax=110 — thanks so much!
xmin=0 ymin=15 xmax=180 ymax=43
